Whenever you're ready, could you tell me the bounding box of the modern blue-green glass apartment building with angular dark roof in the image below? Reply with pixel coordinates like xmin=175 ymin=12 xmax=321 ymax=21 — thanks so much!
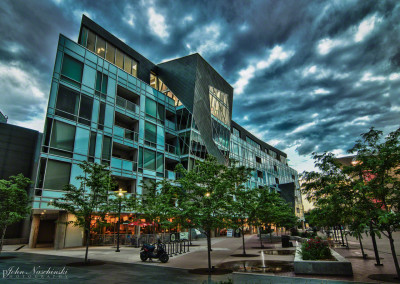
xmin=30 ymin=16 xmax=302 ymax=248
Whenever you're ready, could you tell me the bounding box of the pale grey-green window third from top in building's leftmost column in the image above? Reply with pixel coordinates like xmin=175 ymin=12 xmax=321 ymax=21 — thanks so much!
xmin=50 ymin=120 xmax=75 ymax=158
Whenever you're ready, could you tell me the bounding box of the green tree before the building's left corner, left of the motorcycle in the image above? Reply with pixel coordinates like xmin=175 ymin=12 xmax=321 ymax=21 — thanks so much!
xmin=53 ymin=161 xmax=114 ymax=264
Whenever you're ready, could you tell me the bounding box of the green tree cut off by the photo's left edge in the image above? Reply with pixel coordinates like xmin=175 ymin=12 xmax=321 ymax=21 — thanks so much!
xmin=0 ymin=174 xmax=31 ymax=253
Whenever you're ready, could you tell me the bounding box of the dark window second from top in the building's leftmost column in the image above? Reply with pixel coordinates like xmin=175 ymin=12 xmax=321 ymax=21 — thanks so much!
xmin=56 ymin=85 xmax=79 ymax=120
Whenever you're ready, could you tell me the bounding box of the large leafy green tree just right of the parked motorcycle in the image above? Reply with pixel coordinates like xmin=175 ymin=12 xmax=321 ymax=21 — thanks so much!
xmin=171 ymin=156 xmax=231 ymax=273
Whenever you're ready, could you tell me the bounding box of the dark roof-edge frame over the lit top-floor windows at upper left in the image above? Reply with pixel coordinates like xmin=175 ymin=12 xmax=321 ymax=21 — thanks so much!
xmin=78 ymin=15 xmax=156 ymax=84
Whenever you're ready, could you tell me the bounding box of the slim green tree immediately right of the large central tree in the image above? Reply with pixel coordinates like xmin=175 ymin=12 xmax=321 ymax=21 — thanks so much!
xmin=227 ymin=160 xmax=258 ymax=256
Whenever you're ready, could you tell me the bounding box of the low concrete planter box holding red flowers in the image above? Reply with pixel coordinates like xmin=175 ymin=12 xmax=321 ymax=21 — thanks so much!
xmin=294 ymin=248 xmax=353 ymax=276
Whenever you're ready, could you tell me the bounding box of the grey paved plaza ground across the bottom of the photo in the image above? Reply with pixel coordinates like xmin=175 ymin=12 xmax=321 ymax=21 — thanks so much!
xmin=0 ymin=235 xmax=399 ymax=283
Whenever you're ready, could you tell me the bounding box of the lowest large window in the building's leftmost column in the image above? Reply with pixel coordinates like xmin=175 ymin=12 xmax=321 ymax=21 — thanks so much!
xmin=44 ymin=160 xmax=71 ymax=190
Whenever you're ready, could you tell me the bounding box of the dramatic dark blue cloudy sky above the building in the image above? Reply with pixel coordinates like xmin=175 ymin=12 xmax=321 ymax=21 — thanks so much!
xmin=0 ymin=0 xmax=400 ymax=172
